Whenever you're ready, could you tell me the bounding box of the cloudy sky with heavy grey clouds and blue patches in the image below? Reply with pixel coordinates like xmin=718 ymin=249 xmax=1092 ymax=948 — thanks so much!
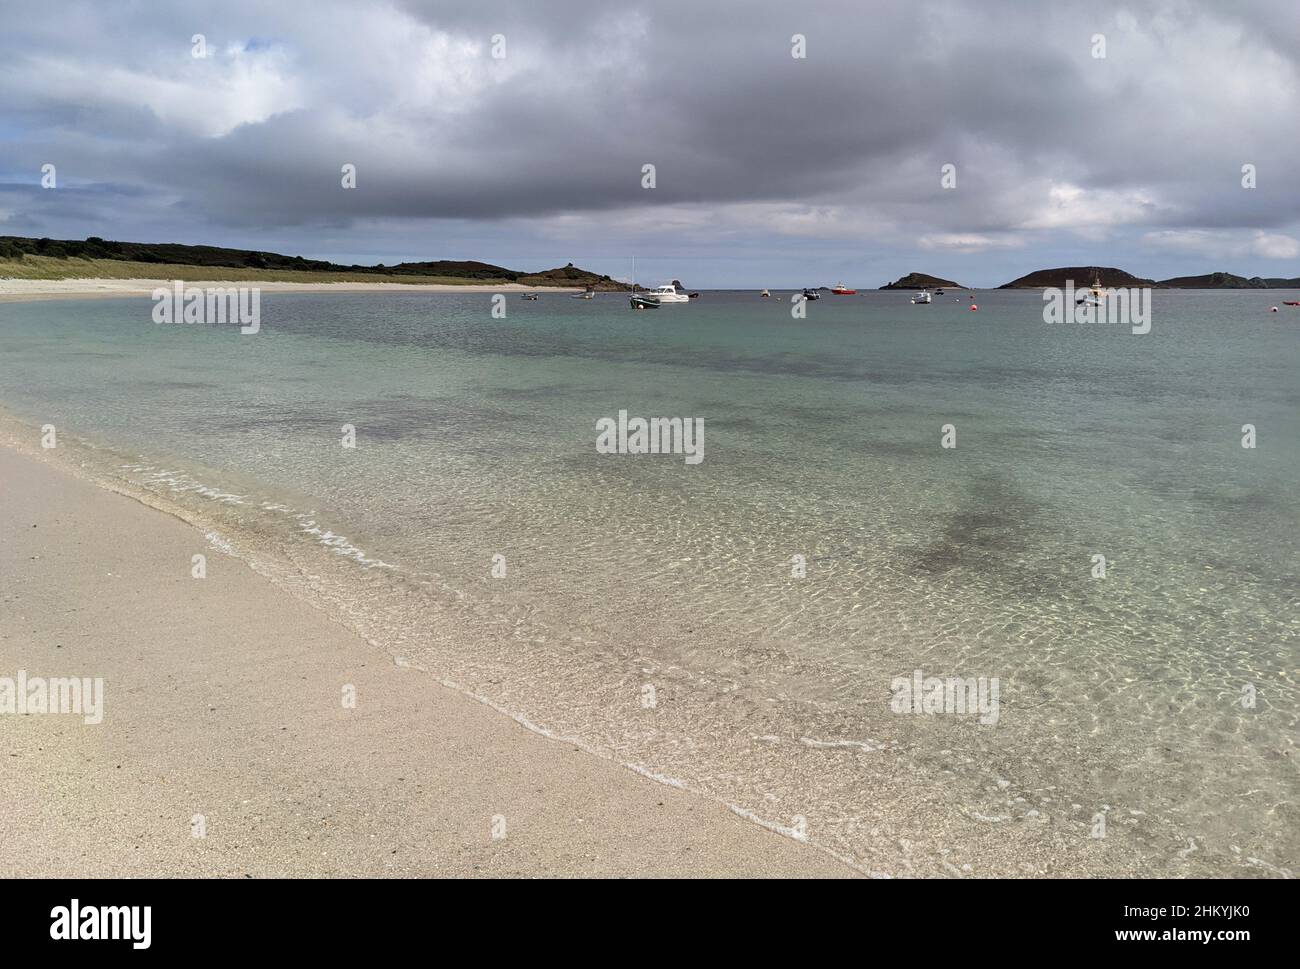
xmin=0 ymin=0 xmax=1300 ymax=286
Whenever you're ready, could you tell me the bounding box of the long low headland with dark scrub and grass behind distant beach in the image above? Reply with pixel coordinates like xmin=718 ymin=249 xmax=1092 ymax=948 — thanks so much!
xmin=0 ymin=235 xmax=631 ymax=291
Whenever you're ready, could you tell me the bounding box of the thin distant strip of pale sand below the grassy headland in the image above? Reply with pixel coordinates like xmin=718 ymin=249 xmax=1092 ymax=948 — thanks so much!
xmin=0 ymin=278 xmax=581 ymax=303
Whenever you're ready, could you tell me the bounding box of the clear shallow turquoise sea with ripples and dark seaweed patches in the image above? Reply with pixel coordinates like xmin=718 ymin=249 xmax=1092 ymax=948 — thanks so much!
xmin=0 ymin=291 xmax=1300 ymax=875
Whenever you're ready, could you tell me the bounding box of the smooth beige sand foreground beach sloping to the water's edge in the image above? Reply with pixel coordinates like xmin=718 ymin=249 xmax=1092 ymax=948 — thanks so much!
xmin=0 ymin=447 xmax=853 ymax=877
